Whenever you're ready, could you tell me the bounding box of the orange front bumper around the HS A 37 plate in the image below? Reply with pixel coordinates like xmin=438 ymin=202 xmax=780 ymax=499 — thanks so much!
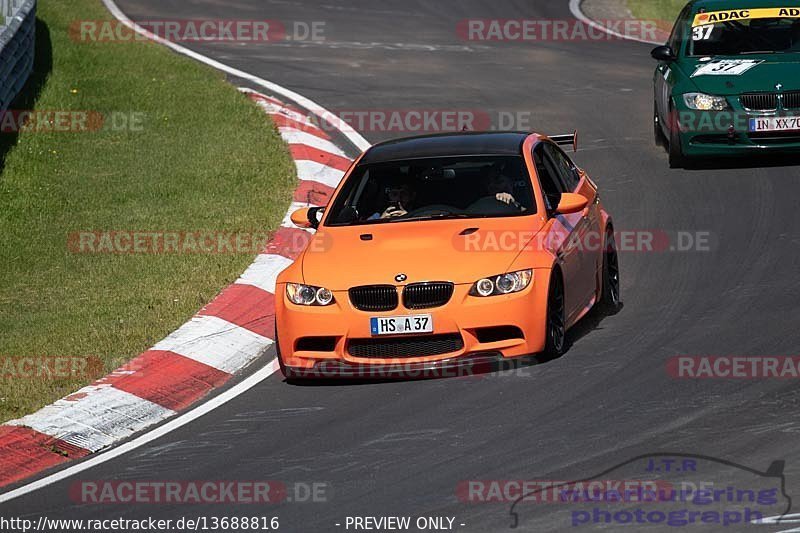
xmin=276 ymin=269 xmax=550 ymax=371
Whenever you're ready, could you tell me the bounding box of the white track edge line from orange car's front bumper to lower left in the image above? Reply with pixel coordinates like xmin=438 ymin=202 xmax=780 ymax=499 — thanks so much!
xmin=0 ymin=359 xmax=279 ymax=503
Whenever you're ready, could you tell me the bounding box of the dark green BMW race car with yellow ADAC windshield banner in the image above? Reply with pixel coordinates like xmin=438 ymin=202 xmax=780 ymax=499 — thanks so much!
xmin=651 ymin=0 xmax=800 ymax=167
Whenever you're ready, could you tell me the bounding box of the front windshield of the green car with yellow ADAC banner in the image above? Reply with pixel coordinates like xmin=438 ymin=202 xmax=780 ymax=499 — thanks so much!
xmin=689 ymin=8 xmax=800 ymax=56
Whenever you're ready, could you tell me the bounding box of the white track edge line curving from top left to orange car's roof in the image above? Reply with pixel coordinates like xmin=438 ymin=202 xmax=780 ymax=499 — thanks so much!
xmin=103 ymin=0 xmax=370 ymax=150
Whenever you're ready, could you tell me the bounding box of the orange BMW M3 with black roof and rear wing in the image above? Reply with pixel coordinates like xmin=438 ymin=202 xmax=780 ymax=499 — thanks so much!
xmin=276 ymin=133 xmax=620 ymax=378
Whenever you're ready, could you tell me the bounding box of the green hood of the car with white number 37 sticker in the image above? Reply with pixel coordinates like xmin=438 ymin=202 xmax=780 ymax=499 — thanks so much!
xmin=680 ymin=53 xmax=800 ymax=96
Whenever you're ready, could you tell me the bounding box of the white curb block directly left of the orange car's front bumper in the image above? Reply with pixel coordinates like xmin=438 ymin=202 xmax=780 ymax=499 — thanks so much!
xmin=152 ymin=315 xmax=272 ymax=374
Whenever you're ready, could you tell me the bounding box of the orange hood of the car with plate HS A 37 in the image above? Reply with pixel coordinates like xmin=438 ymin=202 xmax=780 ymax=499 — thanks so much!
xmin=301 ymin=216 xmax=542 ymax=290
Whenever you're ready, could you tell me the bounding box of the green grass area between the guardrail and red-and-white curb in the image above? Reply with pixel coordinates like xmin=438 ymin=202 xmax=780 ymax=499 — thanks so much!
xmin=0 ymin=0 xmax=296 ymax=421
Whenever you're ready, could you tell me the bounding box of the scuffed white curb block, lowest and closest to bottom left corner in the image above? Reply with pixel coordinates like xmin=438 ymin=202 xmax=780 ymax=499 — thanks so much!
xmin=8 ymin=385 xmax=176 ymax=452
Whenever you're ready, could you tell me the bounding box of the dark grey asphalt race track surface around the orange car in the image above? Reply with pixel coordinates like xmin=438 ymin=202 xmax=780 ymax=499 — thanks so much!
xmin=3 ymin=0 xmax=800 ymax=532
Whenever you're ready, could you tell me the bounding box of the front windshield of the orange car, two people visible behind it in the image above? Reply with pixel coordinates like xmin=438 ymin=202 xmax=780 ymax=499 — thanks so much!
xmin=325 ymin=156 xmax=536 ymax=226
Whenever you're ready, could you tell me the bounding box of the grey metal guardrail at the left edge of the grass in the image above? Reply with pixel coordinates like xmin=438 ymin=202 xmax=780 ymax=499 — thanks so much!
xmin=0 ymin=0 xmax=36 ymax=113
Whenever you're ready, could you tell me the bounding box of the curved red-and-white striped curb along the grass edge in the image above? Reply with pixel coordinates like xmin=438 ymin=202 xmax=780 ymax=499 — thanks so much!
xmin=0 ymin=89 xmax=351 ymax=486
